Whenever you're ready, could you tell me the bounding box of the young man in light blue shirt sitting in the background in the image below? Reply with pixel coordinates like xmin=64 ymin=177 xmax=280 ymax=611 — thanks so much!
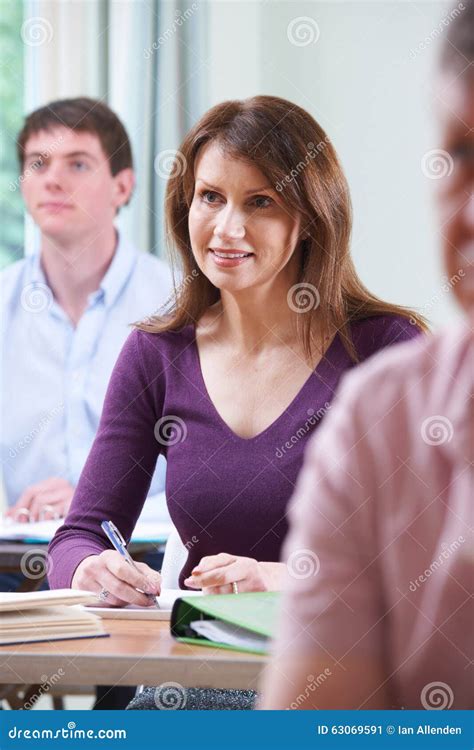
xmin=0 ymin=98 xmax=172 ymax=712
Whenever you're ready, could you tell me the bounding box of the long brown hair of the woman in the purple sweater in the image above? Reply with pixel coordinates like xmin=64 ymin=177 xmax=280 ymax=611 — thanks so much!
xmin=136 ymin=96 xmax=427 ymax=361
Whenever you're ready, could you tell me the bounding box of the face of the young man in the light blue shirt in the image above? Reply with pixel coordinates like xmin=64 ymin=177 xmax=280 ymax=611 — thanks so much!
xmin=21 ymin=127 xmax=134 ymax=244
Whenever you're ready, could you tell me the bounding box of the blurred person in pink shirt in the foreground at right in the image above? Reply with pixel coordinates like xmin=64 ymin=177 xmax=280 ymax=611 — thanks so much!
xmin=260 ymin=0 xmax=474 ymax=709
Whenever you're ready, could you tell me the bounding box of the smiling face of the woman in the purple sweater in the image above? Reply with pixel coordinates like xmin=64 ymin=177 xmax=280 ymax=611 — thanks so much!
xmin=189 ymin=141 xmax=301 ymax=293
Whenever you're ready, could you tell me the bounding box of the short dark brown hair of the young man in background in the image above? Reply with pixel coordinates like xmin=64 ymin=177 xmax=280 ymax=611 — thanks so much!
xmin=17 ymin=96 xmax=133 ymax=177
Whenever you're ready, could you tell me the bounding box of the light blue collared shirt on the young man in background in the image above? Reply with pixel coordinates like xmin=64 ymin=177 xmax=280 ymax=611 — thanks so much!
xmin=0 ymin=238 xmax=172 ymax=520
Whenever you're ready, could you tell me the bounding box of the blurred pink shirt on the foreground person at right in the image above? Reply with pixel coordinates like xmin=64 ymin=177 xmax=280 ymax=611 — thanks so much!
xmin=277 ymin=325 xmax=474 ymax=709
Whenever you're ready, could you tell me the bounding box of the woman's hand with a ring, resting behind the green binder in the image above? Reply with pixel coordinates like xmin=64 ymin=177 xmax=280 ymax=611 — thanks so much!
xmin=184 ymin=552 xmax=286 ymax=594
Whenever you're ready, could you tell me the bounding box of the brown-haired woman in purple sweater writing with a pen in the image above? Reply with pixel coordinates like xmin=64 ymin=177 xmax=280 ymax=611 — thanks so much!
xmin=50 ymin=96 xmax=425 ymax=704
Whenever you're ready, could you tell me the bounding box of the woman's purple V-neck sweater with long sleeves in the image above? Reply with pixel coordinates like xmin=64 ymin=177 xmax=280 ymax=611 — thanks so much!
xmin=49 ymin=315 xmax=419 ymax=588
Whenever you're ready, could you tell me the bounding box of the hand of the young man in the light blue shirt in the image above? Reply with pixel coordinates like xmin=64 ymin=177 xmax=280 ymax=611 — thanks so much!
xmin=5 ymin=477 xmax=75 ymax=522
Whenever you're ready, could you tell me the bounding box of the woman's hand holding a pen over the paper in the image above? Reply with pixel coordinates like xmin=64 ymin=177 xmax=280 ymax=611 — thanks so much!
xmin=71 ymin=550 xmax=161 ymax=607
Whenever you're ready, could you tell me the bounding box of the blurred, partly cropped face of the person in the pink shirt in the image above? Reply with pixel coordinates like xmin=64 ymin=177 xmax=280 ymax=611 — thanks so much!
xmin=437 ymin=73 xmax=474 ymax=319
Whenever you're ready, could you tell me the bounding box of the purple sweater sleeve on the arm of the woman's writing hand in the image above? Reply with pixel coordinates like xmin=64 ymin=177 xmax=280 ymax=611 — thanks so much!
xmin=48 ymin=330 xmax=164 ymax=589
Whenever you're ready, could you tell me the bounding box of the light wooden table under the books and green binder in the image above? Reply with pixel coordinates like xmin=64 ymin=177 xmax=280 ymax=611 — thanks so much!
xmin=0 ymin=620 xmax=267 ymax=689
